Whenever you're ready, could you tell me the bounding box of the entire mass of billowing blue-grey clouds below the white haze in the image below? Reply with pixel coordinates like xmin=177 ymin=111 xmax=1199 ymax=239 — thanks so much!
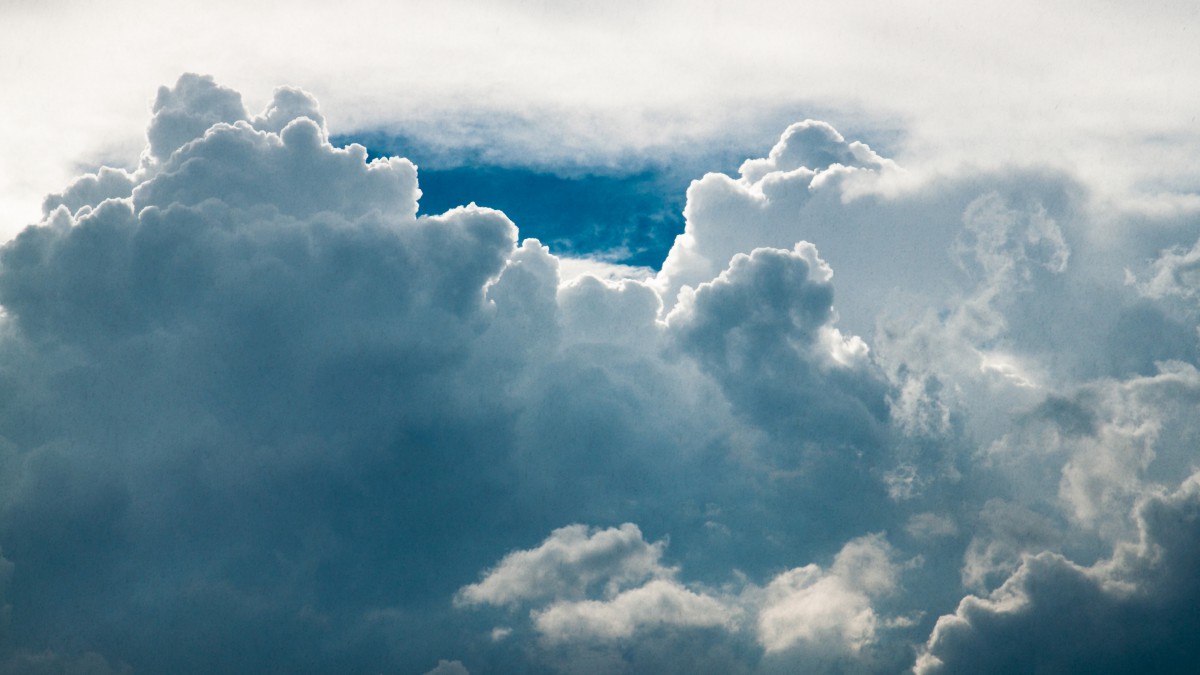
xmin=0 ymin=74 xmax=1200 ymax=673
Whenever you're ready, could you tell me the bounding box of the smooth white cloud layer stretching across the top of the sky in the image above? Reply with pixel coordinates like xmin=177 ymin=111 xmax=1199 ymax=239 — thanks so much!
xmin=9 ymin=0 xmax=1200 ymax=241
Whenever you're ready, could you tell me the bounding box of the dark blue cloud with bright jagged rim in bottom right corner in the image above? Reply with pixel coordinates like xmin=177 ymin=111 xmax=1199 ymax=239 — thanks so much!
xmin=916 ymin=474 xmax=1200 ymax=674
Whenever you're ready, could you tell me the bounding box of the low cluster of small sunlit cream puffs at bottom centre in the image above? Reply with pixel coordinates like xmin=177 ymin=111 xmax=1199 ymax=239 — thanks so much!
xmin=456 ymin=524 xmax=900 ymax=657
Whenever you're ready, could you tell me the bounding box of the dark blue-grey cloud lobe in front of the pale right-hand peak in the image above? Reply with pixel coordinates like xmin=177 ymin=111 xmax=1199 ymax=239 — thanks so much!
xmin=667 ymin=243 xmax=887 ymax=446
